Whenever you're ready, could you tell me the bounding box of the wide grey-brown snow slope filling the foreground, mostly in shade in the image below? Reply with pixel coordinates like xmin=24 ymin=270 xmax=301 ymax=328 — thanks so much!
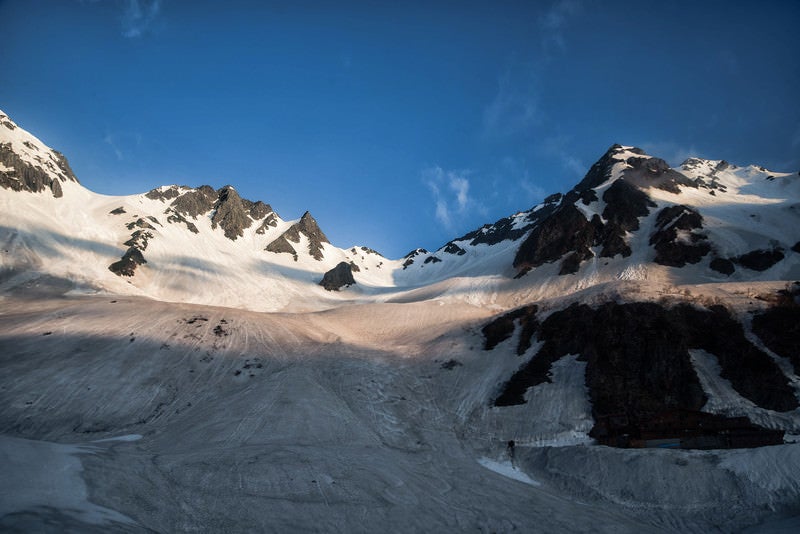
xmin=0 ymin=296 xmax=800 ymax=532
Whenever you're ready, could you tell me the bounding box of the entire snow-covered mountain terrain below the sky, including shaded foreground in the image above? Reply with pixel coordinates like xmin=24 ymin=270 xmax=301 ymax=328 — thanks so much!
xmin=0 ymin=108 xmax=800 ymax=532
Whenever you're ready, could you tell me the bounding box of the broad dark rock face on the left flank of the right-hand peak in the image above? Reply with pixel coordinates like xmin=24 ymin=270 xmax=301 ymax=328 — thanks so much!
xmin=514 ymin=204 xmax=595 ymax=272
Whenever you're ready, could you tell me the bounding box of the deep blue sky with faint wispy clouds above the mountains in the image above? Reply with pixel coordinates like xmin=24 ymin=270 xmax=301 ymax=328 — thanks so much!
xmin=0 ymin=0 xmax=800 ymax=258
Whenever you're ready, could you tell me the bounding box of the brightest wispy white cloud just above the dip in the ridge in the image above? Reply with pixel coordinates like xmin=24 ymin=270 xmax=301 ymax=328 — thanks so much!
xmin=422 ymin=166 xmax=478 ymax=230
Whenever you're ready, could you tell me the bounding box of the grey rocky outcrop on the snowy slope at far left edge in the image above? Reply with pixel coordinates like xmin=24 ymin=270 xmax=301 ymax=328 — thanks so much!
xmin=0 ymin=143 xmax=78 ymax=198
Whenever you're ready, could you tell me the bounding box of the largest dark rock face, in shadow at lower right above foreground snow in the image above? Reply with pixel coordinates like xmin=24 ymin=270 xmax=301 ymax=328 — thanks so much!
xmin=485 ymin=302 xmax=798 ymax=448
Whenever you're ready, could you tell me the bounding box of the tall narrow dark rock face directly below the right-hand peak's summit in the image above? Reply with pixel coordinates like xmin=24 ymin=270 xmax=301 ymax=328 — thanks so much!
xmin=600 ymin=180 xmax=656 ymax=258
